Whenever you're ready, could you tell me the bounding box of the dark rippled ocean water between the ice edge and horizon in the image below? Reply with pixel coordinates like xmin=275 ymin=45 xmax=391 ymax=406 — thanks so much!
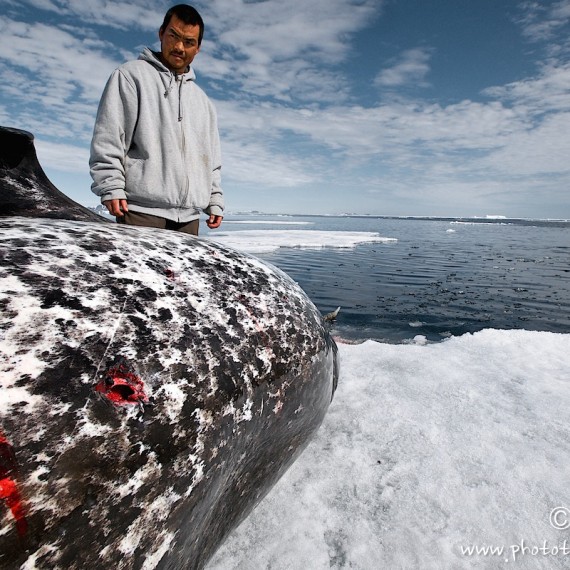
xmin=206 ymin=216 xmax=570 ymax=343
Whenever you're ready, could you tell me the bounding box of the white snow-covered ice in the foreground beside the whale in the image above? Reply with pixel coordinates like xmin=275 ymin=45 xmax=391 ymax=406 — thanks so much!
xmin=207 ymin=329 xmax=570 ymax=570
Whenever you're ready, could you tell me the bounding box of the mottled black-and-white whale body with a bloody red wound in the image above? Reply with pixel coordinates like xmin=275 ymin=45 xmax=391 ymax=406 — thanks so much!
xmin=0 ymin=126 xmax=338 ymax=570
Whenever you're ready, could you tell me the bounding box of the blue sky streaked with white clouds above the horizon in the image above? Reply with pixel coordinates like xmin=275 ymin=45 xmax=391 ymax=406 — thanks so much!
xmin=0 ymin=0 xmax=570 ymax=218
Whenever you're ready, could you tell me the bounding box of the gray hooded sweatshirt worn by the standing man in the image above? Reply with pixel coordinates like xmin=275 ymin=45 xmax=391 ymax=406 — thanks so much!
xmin=89 ymin=48 xmax=224 ymax=222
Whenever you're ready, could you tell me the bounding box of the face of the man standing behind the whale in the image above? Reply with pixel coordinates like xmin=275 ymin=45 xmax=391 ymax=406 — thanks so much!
xmin=158 ymin=15 xmax=200 ymax=73
